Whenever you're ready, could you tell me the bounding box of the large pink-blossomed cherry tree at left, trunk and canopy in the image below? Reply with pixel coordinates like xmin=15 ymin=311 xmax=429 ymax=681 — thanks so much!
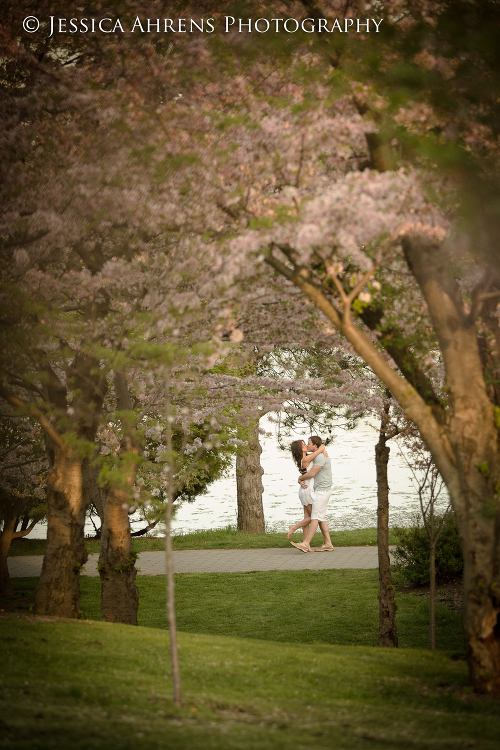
xmin=2 ymin=6 xmax=250 ymax=616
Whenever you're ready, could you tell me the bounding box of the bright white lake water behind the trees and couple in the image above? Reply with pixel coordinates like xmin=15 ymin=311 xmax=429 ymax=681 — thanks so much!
xmin=30 ymin=418 xmax=440 ymax=538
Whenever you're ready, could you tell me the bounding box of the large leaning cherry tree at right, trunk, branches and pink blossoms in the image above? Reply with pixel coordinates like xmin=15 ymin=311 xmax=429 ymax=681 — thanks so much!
xmin=216 ymin=4 xmax=499 ymax=694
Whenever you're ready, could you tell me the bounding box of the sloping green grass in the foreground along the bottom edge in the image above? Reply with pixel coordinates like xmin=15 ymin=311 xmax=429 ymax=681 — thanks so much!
xmin=0 ymin=616 xmax=500 ymax=750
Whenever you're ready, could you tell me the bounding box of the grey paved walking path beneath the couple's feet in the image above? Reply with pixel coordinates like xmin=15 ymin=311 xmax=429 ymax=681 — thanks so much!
xmin=8 ymin=547 xmax=390 ymax=578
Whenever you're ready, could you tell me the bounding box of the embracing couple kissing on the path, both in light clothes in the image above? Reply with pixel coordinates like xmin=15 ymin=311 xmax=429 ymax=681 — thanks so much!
xmin=286 ymin=435 xmax=334 ymax=552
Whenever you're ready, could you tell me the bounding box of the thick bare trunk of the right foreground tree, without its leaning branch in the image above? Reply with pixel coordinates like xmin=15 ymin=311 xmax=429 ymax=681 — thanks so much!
xmin=403 ymin=237 xmax=500 ymax=697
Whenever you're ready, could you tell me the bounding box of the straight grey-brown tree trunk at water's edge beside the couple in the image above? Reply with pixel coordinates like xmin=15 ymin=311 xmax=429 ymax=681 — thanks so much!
xmin=236 ymin=419 xmax=266 ymax=534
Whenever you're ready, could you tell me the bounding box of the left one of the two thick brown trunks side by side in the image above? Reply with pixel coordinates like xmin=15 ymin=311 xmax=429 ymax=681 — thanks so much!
xmin=35 ymin=445 xmax=88 ymax=617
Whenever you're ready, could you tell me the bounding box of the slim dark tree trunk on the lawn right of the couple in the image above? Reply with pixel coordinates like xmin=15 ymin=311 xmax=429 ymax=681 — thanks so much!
xmin=375 ymin=420 xmax=398 ymax=648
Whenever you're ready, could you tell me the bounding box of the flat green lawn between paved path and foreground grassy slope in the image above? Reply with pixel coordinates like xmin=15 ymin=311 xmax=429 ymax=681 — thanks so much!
xmin=4 ymin=570 xmax=463 ymax=655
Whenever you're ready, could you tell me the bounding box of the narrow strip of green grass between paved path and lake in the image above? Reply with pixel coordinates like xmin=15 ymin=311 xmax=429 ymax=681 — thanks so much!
xmin=9 ymin=527 xmax=398 ymax=556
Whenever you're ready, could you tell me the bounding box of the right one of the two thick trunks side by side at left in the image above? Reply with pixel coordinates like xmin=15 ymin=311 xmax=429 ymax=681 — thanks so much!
xmin=99 ymin=487 xmax=139 ymax=625
